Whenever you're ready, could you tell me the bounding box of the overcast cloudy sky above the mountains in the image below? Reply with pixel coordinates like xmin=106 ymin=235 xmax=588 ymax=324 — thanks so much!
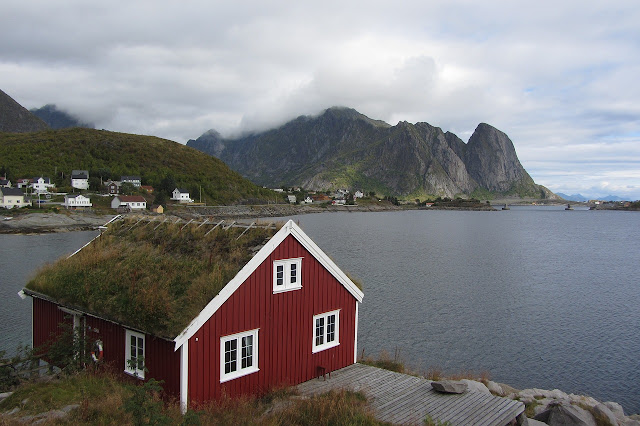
xmin=0 ymin=0 xmax=640 ymax=199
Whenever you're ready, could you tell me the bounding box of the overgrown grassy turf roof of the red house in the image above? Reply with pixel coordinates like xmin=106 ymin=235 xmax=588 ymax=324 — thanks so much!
xmin=27 ymin=220 xmax=280 ymax=339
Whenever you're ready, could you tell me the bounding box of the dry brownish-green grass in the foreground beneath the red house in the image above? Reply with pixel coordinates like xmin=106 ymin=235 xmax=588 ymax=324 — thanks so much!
xmin=0 ymin=373 xmax=383 ymax=425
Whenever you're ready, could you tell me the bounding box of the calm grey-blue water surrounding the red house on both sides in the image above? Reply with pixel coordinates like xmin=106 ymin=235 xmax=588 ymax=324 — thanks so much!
xmin=0 ymin=207 xmax=640 ymax=413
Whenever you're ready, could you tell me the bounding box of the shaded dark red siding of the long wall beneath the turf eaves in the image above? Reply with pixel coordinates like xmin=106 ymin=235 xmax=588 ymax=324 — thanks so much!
xmin=33 ymin=297 xmax=180 ymax=396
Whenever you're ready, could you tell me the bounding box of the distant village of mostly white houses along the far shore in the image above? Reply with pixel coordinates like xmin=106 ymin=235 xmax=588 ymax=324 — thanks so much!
xmin=0 ymin=170 xmax=373 ymax=213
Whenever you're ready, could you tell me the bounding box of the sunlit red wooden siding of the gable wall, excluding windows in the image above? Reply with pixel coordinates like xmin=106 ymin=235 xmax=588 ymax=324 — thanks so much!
xmin=188 ymin=236 xmax=357 ymax=403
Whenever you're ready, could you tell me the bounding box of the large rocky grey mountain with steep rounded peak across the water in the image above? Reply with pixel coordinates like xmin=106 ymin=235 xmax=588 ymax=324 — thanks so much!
xmin=187 ymin=107 xmax=555 ymax=198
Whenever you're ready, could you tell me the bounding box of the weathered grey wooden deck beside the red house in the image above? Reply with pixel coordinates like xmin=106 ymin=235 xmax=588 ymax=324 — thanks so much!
xmin=298 ymin=364 xmax=524 ymax=426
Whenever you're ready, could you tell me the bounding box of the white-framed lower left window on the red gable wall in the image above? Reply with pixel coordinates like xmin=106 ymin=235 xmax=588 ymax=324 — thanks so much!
xmin=220 ymin=328 xmax=259 ymax=383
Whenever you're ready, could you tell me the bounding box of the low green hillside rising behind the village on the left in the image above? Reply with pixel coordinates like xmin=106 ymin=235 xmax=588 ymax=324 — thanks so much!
xmin=0 ymin=128 xmax=277 ymax=204
